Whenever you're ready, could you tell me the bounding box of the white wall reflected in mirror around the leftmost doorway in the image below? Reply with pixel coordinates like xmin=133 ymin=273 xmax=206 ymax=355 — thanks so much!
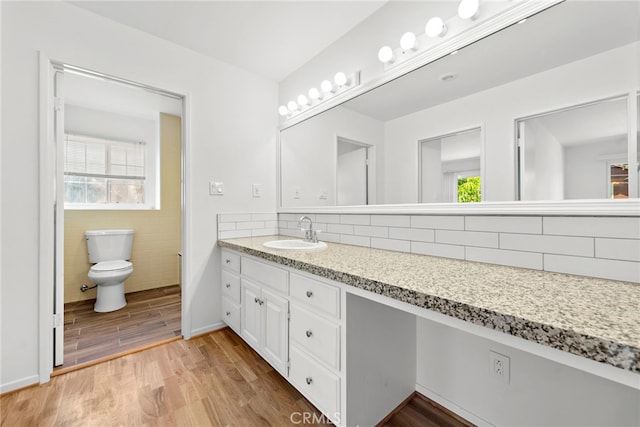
xmin=280 ymin=107 xmax=384 ymax=207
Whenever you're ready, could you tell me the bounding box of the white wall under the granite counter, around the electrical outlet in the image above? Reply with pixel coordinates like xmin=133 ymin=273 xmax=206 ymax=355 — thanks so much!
xmin=416 ymin=317 xmax=640 ymax=427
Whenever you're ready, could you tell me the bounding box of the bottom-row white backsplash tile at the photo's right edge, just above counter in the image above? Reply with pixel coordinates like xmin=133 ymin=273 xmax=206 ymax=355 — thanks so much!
xmin=544 ymin=254 xmax=640 ymax=283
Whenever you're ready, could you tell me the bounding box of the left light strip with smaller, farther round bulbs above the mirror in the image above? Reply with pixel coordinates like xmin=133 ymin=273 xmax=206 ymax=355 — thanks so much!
xmin=278 ymin=71 xmax=360 ymax=119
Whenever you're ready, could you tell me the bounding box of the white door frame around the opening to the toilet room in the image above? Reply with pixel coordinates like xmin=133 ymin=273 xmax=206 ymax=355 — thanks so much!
xmin=38 ymin=51 xmax=191 ymax=384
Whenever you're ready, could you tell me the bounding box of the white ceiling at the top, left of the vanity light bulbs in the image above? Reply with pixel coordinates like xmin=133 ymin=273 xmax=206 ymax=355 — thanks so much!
xmin=70 ymin=0 xmax=387 ymax=82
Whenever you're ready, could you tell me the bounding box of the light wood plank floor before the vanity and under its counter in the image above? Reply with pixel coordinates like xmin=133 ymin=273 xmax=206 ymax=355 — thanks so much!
xmin=0 ymin=328 xmax=470 ymax=427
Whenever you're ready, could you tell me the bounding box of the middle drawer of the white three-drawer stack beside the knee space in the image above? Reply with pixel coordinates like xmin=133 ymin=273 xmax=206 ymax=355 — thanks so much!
xmin=289 ymin=304 xmax=340 ymax=370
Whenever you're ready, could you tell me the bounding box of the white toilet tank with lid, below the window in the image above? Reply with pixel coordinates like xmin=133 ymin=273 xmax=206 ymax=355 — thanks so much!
xmin=84 ymin=230 xmax=133 ymax=264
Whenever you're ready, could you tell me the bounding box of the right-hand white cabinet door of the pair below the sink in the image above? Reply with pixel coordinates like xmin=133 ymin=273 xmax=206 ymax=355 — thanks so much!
xmin=260 ymin=288 xmax=289 ymax=376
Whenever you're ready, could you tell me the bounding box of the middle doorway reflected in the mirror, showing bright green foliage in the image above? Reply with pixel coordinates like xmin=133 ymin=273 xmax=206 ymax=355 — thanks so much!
xmin=419 ymin=128 xmax=482 ymax=203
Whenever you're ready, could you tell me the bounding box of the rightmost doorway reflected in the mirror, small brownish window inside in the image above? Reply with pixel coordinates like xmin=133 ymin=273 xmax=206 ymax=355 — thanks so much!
xmin=517 ymin=96 xmax=629 ymax=200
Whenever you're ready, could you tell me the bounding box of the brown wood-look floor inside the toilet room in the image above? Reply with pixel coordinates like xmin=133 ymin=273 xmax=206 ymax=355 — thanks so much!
xmin=58 ymin=285 xmax=181 ymax=369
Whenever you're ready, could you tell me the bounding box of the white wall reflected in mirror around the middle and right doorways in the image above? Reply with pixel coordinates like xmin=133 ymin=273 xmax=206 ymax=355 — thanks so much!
xmin=384 ymin=43 xmax=640 ymax=203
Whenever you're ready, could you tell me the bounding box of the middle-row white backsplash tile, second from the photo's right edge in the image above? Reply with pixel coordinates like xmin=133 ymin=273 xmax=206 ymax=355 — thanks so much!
xmin=500 ymin=233 xmax=594 ymax=257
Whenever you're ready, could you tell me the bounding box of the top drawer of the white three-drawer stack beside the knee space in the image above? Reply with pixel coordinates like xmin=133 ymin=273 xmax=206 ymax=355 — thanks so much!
xmin=291 ymin=273 xmax=340 ymax=318
